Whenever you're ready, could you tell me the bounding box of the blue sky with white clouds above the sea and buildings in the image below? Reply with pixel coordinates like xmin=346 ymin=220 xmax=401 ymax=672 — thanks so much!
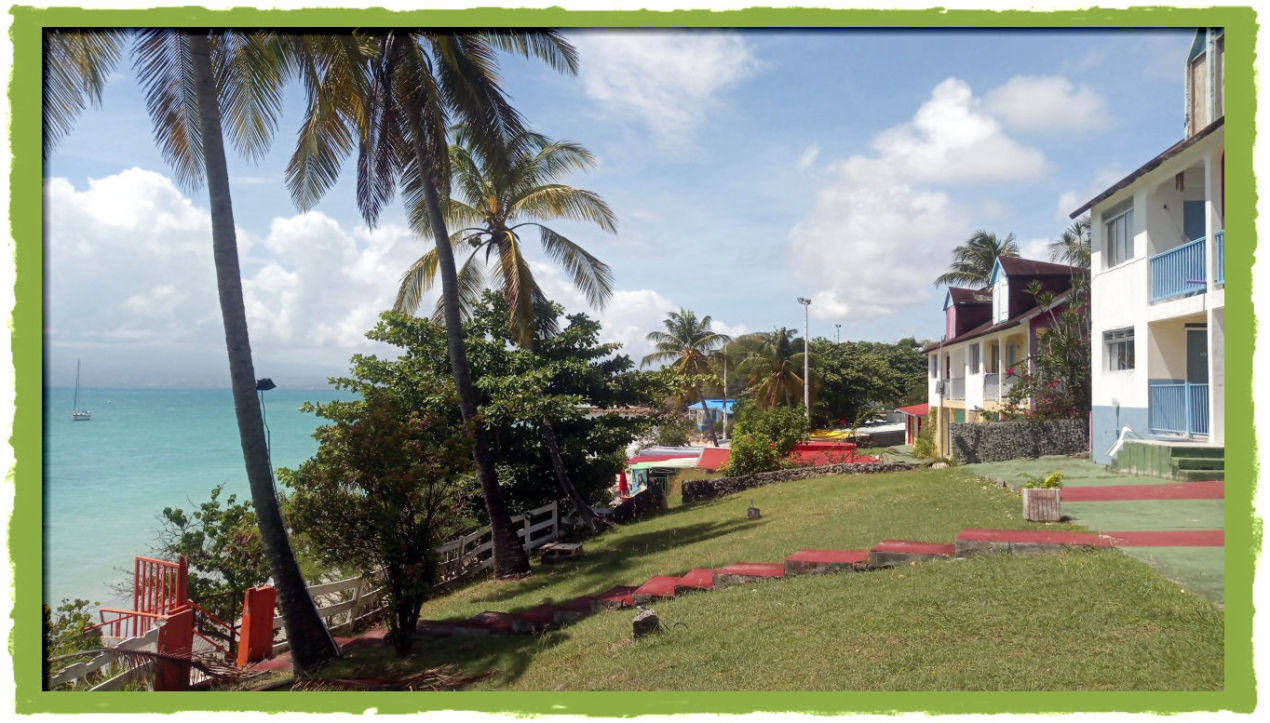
xmin=44 ymin=23 xmax=1193 ymax=388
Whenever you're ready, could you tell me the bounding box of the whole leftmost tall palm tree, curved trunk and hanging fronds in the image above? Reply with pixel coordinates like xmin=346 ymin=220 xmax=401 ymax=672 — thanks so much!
xmin=44 ymin=29 xmax=339 ymax=672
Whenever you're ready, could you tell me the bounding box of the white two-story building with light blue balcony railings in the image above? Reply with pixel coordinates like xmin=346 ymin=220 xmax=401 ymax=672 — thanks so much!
xmin=1072 ymin=28 xmax=1226 ymax=479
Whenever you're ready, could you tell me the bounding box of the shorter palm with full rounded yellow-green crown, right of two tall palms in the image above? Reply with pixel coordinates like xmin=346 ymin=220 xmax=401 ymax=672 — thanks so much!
xmin=395 ymin=126 xmax=617 ymax=530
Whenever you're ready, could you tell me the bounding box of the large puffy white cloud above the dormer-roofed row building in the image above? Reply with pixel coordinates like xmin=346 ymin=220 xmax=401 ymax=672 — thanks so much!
xmin=786 ymin=78 xmax=1048 ymax=321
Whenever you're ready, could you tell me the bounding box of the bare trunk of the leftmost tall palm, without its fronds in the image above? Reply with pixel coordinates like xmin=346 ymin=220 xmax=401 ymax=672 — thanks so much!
xmin=189 ymin=32 xmax=339 ymax=673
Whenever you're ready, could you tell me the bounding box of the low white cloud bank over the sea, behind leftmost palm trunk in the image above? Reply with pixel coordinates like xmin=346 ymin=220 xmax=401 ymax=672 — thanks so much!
xmin=44 ymin=169 xmax=434 ymax=381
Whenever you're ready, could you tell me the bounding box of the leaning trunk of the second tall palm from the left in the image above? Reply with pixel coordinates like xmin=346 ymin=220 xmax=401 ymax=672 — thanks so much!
xmin=414 ymin=137 xmax=530 ymax=578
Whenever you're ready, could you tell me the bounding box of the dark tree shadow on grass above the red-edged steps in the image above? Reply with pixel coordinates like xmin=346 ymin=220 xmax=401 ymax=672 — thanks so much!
xmin=475 ymin=510 xmax=766 ymax=612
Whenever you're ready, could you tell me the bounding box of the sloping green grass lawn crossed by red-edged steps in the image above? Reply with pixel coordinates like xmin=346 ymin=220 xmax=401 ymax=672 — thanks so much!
xmin=314 ymin=468 xmax=1223 ymax=691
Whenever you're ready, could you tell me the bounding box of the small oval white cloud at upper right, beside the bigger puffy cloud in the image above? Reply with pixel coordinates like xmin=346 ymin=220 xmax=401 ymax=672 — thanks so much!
xmin=983 ymin=75 xmax=1111 ymax=131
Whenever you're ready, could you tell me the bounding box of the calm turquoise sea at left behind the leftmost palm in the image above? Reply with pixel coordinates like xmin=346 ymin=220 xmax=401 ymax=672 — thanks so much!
xmin=43 ymin=388 xmax=352 ymax=607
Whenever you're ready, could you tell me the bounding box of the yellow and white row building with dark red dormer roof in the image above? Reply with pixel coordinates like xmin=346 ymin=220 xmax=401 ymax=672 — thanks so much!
xmin=923 ymin=257 xmax=1085 ymax=456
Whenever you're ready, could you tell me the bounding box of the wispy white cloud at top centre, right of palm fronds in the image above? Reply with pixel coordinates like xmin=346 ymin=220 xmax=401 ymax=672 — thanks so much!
xmin=570 ymin=30 xmax=761 ymax=149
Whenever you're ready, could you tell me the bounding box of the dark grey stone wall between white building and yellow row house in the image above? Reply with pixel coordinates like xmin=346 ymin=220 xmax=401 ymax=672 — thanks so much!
xmin=949 ymin=419 xmax=1090 ymax=464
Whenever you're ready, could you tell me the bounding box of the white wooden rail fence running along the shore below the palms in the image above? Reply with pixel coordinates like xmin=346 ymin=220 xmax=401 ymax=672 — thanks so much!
xmin=48 ymin=502 xmax=560 ymax=690
